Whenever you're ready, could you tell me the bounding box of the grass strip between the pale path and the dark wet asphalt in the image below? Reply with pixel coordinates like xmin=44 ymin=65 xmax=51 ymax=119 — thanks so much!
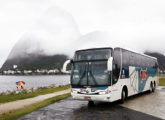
xmin=0 ymin=93 xmax=70 ymax=120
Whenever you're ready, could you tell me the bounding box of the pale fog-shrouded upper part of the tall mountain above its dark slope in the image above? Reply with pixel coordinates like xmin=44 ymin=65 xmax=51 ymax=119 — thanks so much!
xmin=9 ymin=7 xmax=81 ymax=59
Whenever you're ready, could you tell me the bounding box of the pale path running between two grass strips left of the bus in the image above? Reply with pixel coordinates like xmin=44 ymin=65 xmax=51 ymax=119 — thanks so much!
xmin=0 ymin=89 xmax=70 ymax=115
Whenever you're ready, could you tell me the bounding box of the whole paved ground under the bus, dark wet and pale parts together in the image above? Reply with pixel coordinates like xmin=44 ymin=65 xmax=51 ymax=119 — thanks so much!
xmin=19 ymin=88 xmax=165 ymax=120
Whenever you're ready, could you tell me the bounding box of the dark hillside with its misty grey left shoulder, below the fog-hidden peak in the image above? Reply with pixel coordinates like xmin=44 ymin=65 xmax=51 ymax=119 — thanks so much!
xmin=1 ymin=39 xmax=68 ymax=71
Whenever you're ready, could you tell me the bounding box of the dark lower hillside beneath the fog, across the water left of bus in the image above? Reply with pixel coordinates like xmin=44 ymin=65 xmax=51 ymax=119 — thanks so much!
xmin=2 ymin=55 xmax=68 ymax=70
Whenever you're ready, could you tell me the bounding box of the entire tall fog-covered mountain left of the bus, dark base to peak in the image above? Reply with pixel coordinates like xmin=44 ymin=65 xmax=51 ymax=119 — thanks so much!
xmin=2 ymin=7 xmax=80 ymax=70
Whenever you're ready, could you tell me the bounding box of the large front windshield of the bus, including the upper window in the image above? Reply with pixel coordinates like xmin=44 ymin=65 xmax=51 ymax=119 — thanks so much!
xmin=71 ymin=49 xmax=111 ymax=86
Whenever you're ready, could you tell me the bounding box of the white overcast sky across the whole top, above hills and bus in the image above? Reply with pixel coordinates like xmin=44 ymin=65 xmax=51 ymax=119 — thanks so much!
xmin=0 ymin=0 xmax=165 ymax=66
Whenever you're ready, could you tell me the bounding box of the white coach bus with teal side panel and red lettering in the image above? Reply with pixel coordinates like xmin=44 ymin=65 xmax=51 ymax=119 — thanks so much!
xmin=63 ymin=47 xmax=158 ymax=104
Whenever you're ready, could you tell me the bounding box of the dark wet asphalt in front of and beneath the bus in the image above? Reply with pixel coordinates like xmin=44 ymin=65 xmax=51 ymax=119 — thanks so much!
xmin=19 ymin=88 xmax=165 ymax=120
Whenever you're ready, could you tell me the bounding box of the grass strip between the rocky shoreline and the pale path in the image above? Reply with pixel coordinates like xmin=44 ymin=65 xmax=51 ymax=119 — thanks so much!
xmin=0 ymin=85 xmax=70 ymax=103
